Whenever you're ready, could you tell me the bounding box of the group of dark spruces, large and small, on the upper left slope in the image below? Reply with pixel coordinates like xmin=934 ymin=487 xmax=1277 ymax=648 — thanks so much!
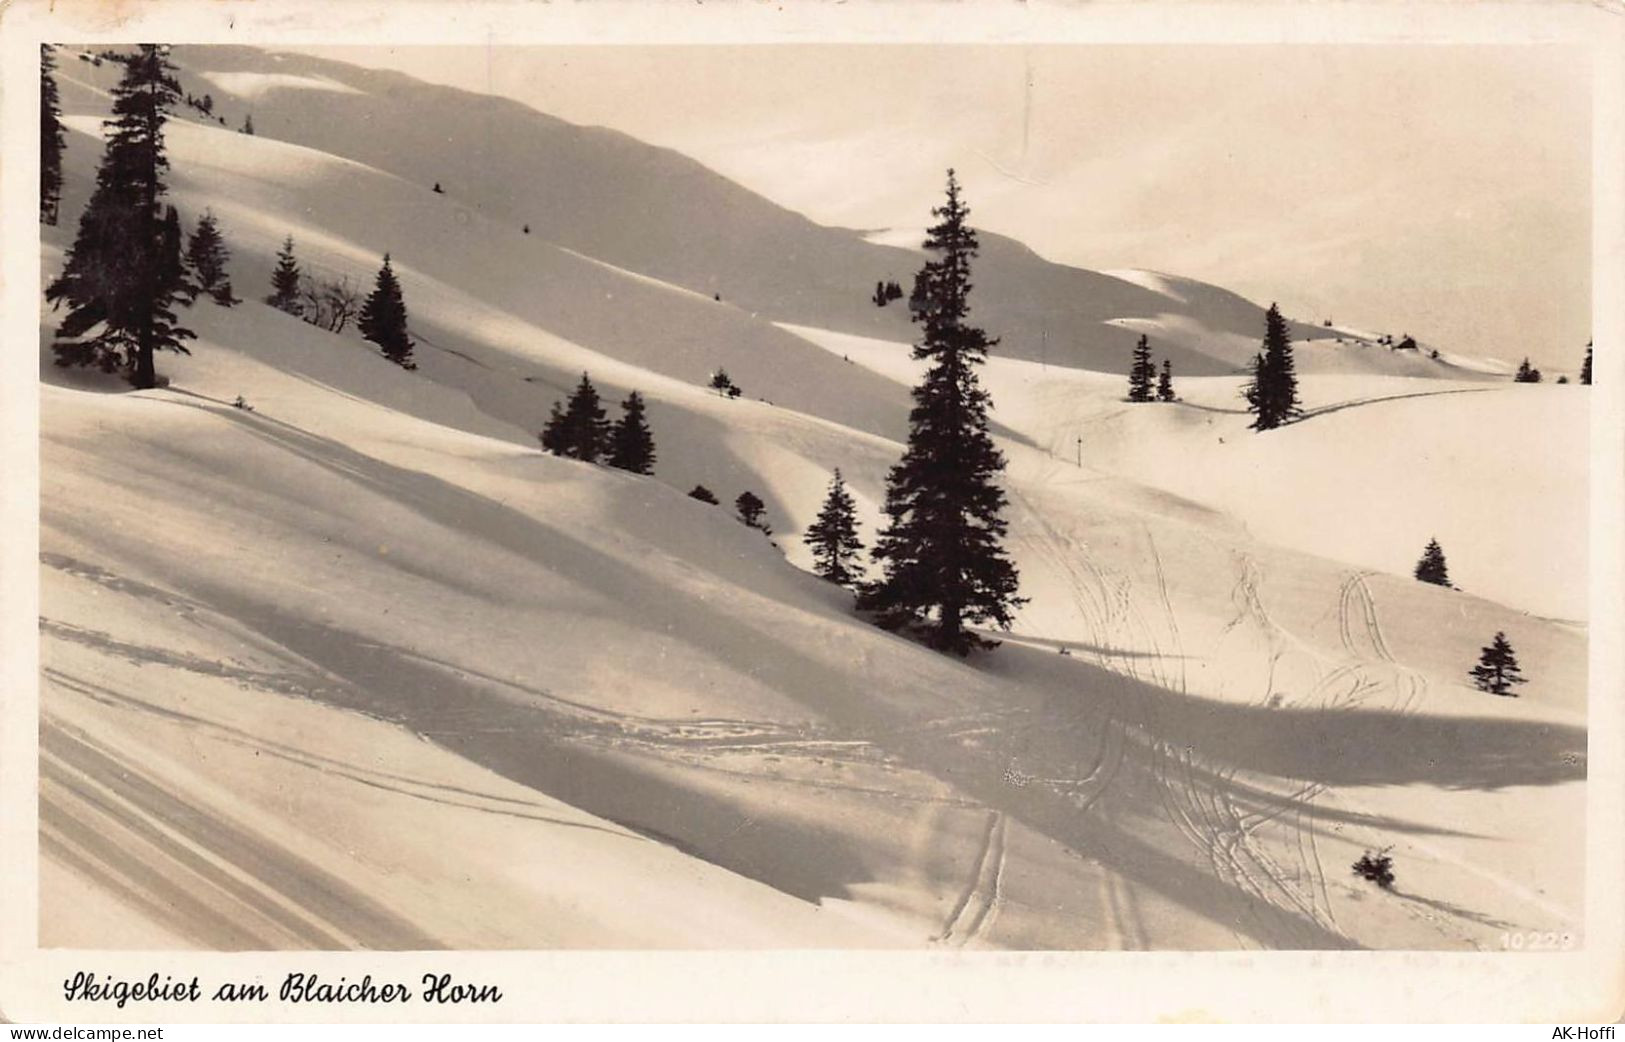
xmin=41 ymin=44 xmax=416 ymax=389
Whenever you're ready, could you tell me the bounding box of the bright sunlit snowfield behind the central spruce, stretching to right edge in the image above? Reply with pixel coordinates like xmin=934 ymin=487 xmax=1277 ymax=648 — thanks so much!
xmin=787 ymin=327 xmax=1589 ymax=619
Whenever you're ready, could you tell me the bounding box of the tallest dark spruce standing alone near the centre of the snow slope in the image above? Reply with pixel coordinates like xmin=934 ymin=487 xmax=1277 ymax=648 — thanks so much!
xmin=858 ymin=171 xmax=1025 ymax=655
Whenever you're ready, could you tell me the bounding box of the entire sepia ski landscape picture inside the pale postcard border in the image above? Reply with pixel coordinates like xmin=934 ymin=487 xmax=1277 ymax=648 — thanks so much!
xmin=8 ymin=0 xmax=1617 ymax=1020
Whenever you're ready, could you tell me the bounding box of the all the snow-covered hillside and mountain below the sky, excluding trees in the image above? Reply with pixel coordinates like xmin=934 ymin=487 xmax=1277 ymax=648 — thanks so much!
xmin=41 ymin=49 xmax=1586 ymax=948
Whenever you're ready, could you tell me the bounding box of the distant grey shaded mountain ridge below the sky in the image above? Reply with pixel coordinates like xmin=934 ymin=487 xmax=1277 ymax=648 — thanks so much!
xmin=63 ymin=47 xmax=1482 ymax=377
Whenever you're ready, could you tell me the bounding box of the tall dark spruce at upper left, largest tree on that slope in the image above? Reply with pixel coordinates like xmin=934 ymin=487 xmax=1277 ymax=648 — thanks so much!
xmin=46 ymin=44 xmax=193 ymax=389
